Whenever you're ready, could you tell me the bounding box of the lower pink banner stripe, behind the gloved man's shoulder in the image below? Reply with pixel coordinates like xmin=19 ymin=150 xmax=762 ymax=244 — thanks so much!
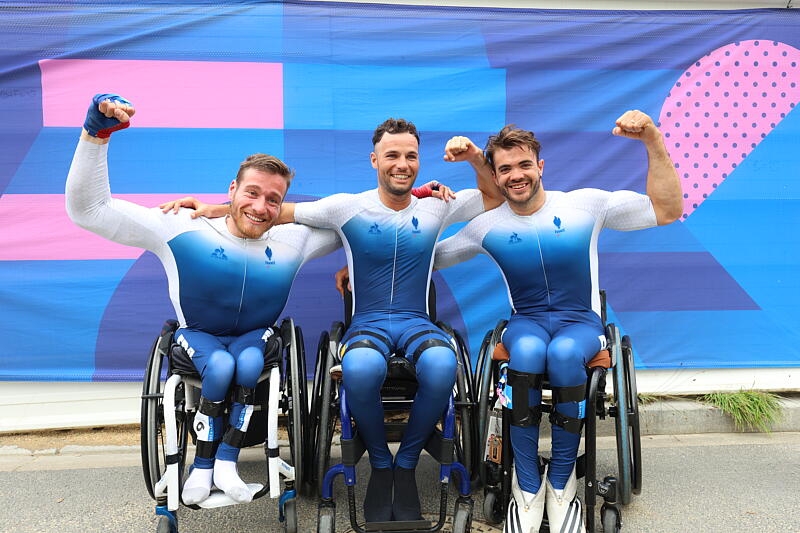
xmin=0 ymin=193 xmax=228 ymax=261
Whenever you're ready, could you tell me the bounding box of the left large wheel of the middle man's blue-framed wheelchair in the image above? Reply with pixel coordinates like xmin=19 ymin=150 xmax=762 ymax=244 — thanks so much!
xmin=313 ymin=323 xmax=344 ymax=494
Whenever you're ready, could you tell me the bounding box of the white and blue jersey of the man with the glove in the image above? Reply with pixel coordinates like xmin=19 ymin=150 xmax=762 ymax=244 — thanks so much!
xmin=66 ymin=141 xmax=341 ymax=336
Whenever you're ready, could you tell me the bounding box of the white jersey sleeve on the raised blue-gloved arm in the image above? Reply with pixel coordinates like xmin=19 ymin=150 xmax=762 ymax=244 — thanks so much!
xmin=65 ymin=140 xmax=167 ymax=251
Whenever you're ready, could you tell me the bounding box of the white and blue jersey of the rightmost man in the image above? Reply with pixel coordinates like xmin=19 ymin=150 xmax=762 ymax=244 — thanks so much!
xmin=434 ymin=189 xmax=656 ymax=315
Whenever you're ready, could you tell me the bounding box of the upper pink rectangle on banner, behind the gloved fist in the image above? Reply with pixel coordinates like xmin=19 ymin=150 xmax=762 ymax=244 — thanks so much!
xmin=39 ymin=59 xmax=283 ymax=129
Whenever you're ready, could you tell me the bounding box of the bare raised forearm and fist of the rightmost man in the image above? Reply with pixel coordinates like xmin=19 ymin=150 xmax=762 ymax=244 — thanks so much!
xmin=611 ymin=110 xmax=683 ymax=225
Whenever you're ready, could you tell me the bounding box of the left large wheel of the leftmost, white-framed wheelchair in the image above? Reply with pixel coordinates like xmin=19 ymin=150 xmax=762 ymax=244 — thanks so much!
xmin=140 ymin=321 xmax=190 ymax=500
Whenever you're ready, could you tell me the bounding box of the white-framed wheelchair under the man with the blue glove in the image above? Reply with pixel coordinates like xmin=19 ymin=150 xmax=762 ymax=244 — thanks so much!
xmin=141 ymin=319 xmax=308 ymax=533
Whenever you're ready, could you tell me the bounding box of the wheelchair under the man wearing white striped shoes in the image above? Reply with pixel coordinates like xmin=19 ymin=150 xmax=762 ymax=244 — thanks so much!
xmin=475 ymin=291 xmax=642 ymax=533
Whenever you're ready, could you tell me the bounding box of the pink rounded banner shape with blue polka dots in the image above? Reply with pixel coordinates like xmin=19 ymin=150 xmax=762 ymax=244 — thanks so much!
xmin=659 ymin=41 xmax=800 ymax=219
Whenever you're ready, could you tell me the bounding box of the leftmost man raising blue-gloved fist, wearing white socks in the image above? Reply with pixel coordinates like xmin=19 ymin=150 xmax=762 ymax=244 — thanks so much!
xmin=66 ymin=94 xmax=341 ymax=505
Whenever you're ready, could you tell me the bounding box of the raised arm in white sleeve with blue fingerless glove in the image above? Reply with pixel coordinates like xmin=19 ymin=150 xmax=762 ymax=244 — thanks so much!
xmin=65 ymin=94 xmax=166 ymax=250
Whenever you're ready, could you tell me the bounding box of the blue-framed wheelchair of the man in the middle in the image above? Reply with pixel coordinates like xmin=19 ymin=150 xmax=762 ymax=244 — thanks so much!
xmin=308 ymin=284 xmax=477 ymax=533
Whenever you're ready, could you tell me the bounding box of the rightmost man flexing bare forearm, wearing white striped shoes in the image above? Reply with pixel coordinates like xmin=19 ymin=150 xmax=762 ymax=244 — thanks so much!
xmin=434 ymin=111 xmax=682 ymax=533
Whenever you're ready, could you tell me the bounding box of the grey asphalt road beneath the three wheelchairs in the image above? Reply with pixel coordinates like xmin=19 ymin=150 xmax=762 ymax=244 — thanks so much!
xmin=0 ymin=433 xmax=800 ymax=533
